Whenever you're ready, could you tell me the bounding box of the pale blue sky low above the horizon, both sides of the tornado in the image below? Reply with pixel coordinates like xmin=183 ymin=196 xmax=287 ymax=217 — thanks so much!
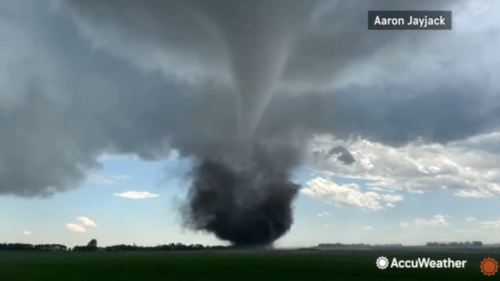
xmin=0 ymin=153 xmax=500 ymax=247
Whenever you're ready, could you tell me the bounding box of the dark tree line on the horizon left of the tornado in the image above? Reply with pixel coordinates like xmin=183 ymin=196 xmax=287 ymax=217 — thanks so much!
xmin=0 ymin=239 xmax=230 ymax=252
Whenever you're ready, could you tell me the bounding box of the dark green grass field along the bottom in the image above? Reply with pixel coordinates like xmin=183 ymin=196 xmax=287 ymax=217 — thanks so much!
xmin=0 ymin=248 xmax=500 ymax=281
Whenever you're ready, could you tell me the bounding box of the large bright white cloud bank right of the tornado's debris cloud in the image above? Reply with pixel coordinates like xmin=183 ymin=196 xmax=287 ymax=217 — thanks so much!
xmin=308 ymin=132 xmax=500 ymax=198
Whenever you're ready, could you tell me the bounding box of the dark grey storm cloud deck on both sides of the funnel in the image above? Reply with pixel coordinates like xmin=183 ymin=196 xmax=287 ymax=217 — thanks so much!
xmin=0 ymin=0 xmax=499 ymax=199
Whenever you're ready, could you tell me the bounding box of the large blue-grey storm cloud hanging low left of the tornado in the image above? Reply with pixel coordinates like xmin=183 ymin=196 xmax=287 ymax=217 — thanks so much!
xmin=0 ymin=1 xmax=238 ymax=197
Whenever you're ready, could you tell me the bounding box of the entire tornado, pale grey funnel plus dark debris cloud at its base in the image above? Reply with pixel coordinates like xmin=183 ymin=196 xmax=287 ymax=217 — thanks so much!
xmin=178 ymin=0 xmax=308 ymax=246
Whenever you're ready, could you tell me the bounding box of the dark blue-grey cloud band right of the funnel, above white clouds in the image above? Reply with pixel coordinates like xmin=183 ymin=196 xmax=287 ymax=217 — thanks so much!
xmin=262 ymin=81 xmax=500 ymax=146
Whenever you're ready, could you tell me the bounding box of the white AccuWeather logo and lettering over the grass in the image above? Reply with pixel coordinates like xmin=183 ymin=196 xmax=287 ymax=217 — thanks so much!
xmin=376 ymin=257 xmax=467 ymax=269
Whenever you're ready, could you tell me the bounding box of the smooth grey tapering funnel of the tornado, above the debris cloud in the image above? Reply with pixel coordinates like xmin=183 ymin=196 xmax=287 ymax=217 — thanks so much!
xmin=188 ymin=0 xmax=312 ymax=138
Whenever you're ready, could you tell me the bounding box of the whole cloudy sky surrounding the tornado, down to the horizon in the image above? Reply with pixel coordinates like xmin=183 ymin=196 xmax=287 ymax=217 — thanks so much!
xmin=0 ymin=0 xmax=500 ymax=247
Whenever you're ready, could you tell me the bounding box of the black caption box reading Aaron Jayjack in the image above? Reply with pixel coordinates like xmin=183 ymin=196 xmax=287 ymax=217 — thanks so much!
xmin=368 ymin=11 xmax=452 ymax=30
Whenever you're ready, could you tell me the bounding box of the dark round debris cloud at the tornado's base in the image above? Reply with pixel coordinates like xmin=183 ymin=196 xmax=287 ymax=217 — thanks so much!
xmin=183 ymin=142 xmax=299 ymax=246
